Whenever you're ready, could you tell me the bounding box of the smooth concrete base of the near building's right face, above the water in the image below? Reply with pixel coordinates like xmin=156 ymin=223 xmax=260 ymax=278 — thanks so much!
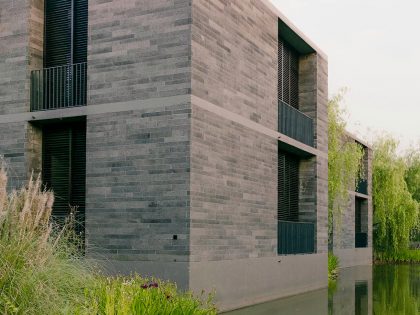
xmin=189 ymin=254 xmax=328 ymax=311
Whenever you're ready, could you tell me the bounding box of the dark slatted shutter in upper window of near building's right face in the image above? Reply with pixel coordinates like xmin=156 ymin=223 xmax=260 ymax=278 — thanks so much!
xmin=278 ymin=38 xmax=299 ymax=109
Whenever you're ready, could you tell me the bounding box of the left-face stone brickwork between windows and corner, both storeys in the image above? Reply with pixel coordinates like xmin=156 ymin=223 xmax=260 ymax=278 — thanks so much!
xmin=86 ymin=0 xmax=195 ymax=261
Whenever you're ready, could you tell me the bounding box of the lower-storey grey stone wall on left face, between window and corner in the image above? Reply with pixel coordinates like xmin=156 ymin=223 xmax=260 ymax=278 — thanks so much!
xmin=86 ymin=104 xmax=190 ymax=261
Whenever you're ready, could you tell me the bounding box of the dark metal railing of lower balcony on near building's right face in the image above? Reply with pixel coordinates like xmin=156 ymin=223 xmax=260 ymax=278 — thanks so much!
xmin=278 ymin=221 xmax=315 ymax=255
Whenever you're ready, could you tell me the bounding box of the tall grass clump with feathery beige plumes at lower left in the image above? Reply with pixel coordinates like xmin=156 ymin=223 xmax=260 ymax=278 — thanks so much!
xmin=0 ymin=169 xmax=93 ymax=314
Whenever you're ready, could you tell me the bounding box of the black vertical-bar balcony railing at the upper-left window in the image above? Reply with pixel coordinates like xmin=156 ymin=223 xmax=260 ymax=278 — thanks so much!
xmin=30 ymin=62 xmax=87 ymax=112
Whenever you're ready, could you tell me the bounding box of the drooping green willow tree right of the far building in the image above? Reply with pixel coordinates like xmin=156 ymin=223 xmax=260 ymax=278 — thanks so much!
xmin=372 ymin=137 xmax=419 ymax=253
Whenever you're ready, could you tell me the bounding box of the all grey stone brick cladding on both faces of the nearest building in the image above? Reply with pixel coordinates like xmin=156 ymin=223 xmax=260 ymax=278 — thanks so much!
xmin=0 ymin=0 xmax=328 ymax=288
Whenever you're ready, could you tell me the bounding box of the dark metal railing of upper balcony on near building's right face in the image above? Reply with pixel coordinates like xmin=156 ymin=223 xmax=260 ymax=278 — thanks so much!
xmin=279 ymin=100 xmax=314 ymax=147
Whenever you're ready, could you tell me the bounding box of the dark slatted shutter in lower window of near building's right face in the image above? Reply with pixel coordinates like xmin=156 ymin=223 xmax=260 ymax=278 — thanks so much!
xmin=277 ymin=150 xmax=299 ymax=222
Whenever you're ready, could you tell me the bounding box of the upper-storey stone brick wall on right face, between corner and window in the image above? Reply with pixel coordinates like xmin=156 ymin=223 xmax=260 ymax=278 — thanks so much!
xmin=191 ymin=0 xmax=278 ymax=130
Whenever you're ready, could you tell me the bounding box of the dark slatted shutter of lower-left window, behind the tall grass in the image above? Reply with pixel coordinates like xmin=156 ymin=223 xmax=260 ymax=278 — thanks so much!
xmin=42 ymin=122 xmax=86 ymax=235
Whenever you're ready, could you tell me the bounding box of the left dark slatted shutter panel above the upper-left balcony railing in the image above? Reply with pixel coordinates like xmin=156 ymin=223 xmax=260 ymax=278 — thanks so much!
xmin=44 ymin=0 xmax=72 ymax=68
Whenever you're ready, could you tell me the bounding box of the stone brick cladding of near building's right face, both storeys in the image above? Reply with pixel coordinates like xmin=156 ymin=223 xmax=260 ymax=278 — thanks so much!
xmin=190 ymin=0 xmax=328 ymax=261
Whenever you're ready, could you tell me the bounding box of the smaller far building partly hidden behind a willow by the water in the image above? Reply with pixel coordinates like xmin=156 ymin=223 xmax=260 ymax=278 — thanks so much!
xmin=330 ymin=133 xmax=373 ymax=268
